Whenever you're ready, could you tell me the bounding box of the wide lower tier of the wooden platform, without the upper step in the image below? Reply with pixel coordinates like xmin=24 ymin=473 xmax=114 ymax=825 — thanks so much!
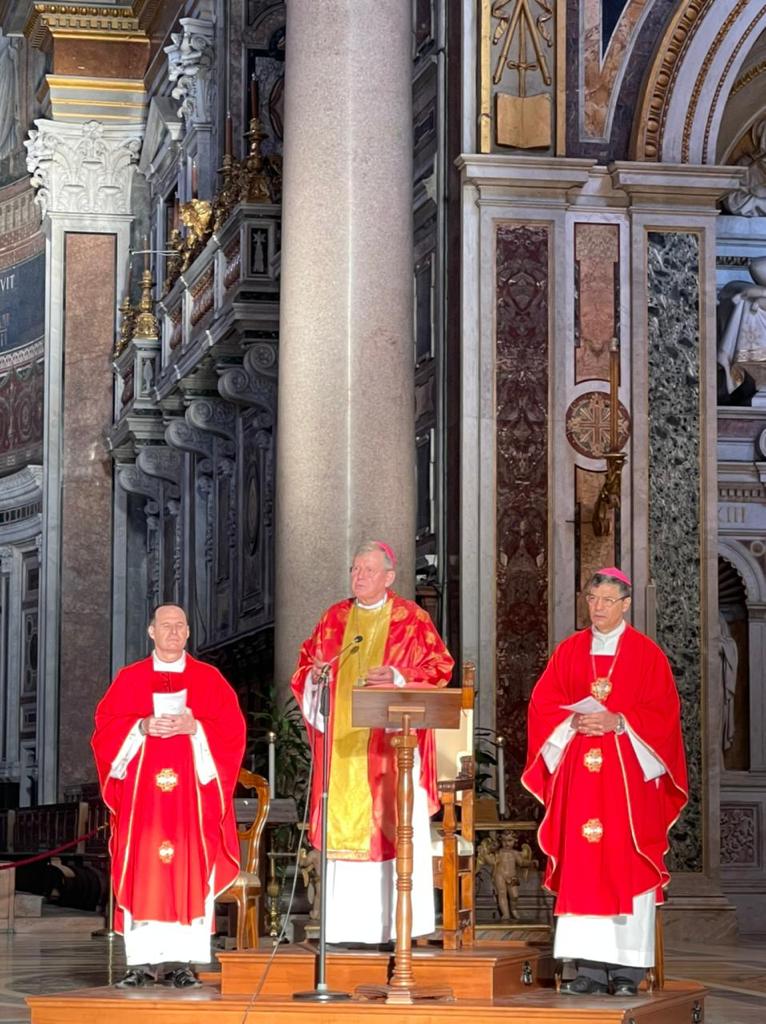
xmin=27 ymin=982 xmax=705 ymax=1024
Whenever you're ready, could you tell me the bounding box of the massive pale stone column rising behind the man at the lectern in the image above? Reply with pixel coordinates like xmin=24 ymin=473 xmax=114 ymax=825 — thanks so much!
xmin=275 ymin=0 xmax=415 ymax=687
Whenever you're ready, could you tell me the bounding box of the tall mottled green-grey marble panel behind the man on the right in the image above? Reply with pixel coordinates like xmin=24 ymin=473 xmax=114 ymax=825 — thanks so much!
xmin=647 ymin=231 xmax=703 ymax=871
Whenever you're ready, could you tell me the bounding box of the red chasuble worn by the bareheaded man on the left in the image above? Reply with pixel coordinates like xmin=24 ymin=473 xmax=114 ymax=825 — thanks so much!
xmin=91 ymin=654 xmax=245 ymax=932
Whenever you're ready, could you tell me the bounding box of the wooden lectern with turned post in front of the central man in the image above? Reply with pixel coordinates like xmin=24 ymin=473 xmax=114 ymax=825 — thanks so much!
xmin=351 ymin=686 xmax=462 ymax=1006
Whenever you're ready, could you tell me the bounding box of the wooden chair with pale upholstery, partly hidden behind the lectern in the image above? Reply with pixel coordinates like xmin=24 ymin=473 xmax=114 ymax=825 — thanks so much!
xmin=432 ymin=662 xmax=476 ymax=949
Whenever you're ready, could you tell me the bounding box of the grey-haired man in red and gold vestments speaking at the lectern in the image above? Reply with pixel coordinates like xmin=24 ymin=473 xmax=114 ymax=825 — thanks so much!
xmin=292 ymin=541 xmax=454 ymax=943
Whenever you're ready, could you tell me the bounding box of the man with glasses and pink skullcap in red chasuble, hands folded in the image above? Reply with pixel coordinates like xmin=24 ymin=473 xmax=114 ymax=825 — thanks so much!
xmin=521 ymin=567 xmax=687 ymax=995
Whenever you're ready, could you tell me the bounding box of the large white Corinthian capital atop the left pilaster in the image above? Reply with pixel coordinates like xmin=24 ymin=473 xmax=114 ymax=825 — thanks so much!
xmin=24 ymin=119 xmax=141 ymax=215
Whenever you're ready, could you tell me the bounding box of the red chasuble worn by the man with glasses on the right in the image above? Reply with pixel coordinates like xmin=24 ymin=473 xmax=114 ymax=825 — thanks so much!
xmin=521 ymin=626 xmax=688 ymax=915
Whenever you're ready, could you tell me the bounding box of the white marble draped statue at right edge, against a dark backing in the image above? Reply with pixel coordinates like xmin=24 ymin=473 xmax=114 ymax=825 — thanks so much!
xmin=717 ymin=257 xmax=766 ymax=408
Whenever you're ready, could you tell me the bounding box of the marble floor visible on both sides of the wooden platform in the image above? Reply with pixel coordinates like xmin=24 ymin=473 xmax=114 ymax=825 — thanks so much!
xmin=0 ymin=931 xmax=766 ymax=1024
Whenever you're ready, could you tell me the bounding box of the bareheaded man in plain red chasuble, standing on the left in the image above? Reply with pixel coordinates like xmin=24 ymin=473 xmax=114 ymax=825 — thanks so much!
xmin=92 ymin=604 xmax=245 ymax=988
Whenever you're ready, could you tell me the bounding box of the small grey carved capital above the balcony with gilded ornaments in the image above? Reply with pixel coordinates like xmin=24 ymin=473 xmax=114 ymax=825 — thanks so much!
xmin=165 ymin=17 xmax=215 ymax=127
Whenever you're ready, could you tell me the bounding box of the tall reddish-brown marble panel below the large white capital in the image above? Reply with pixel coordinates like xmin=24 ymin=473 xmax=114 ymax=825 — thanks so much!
xmin=59 ymin=232 xmax=116 ymax=791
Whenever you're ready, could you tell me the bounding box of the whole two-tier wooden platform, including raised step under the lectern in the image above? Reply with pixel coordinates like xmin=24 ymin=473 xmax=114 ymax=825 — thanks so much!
xmin=27 ymin=942 xmax=706 ymax=1024
